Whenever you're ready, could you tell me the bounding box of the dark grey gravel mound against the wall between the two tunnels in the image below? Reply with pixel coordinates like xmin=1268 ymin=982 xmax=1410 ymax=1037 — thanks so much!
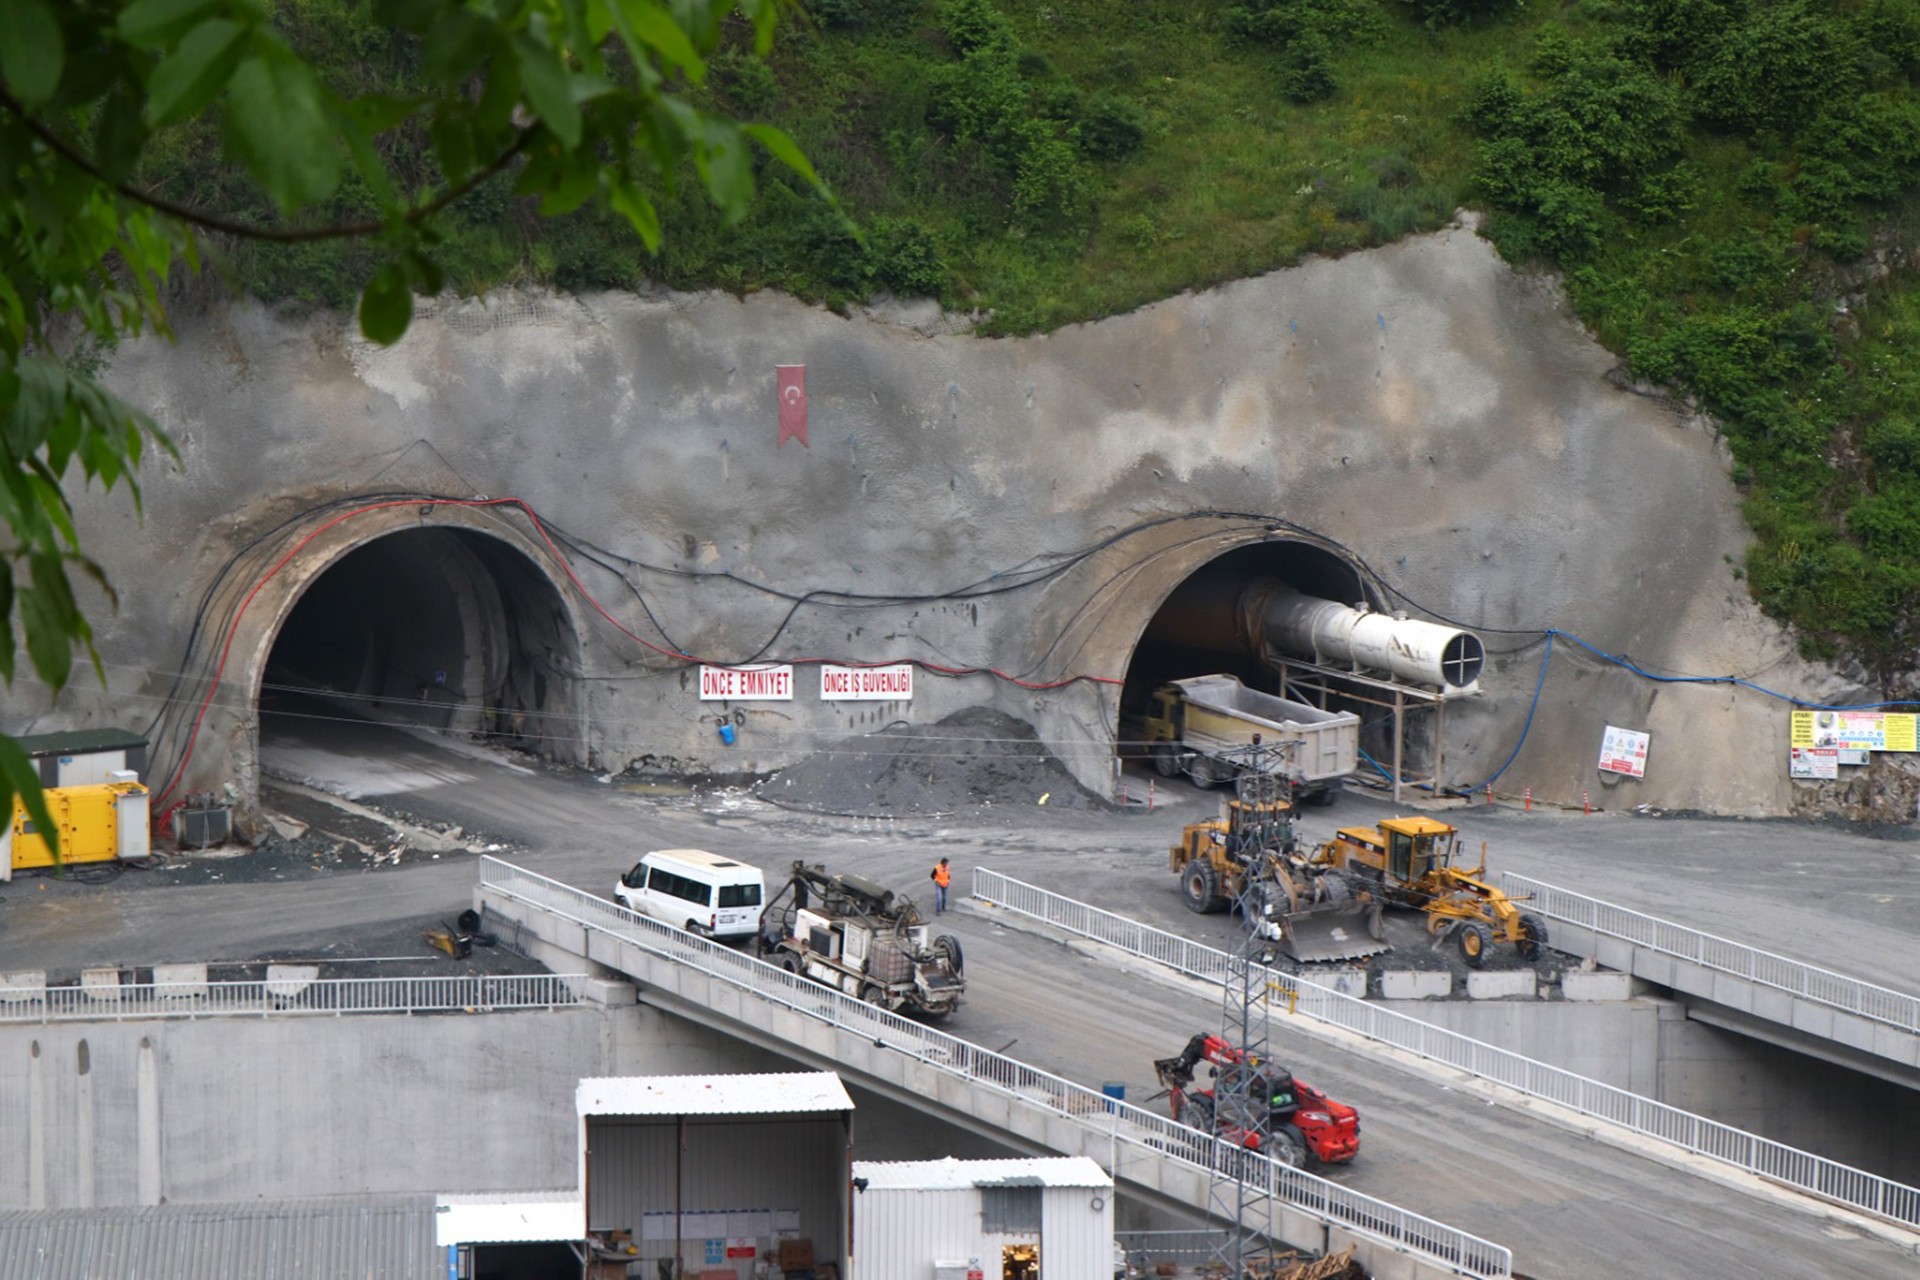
xmin=758 ymin=706 xmax=1106 ymax=818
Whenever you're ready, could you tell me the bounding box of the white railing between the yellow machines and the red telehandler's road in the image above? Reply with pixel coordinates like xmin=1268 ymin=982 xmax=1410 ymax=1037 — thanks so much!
xmin=973 ymin=867 xmax=1920 ymax=1226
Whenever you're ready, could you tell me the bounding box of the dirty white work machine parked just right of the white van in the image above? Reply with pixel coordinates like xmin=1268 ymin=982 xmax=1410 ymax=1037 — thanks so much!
xmin=758 ymin=862 xmax=966 ymax=1019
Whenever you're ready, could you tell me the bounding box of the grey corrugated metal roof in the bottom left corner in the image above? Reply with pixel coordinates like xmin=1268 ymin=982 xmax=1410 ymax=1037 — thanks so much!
xmin=0 ymin=1196 xmax=447 ymax=1280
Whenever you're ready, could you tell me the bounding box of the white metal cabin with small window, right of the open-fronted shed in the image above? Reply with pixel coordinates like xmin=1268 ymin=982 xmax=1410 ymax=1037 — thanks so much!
xmin=852 ymin=1157 xmax=1114 ymax=1280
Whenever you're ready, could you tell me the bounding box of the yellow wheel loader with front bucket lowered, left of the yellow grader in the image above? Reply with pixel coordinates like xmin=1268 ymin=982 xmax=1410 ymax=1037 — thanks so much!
xmin=1167 ymin=787 xmax=1388 ymax=961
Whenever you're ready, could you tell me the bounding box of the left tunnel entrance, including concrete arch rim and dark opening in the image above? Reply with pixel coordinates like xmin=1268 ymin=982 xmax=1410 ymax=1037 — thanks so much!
xmin=190 ymin=501 xmax=593 ymax=825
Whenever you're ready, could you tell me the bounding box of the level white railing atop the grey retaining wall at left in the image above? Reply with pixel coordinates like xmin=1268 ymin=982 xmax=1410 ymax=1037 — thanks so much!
xmin=0 ymin=973 xmax=586 ymax=1023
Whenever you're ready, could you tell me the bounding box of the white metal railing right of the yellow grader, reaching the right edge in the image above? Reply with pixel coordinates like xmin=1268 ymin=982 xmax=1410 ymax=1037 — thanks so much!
xmin=1501 ymin=871 xmax=1920 ymax=1034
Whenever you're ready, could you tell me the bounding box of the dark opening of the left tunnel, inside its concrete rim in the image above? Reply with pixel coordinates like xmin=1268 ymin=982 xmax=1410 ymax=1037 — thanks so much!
xmin=259 ymin=528 xmax=580 ymax=758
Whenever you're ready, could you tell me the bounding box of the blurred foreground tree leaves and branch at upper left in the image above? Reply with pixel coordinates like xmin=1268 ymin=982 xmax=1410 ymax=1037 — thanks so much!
xmin=0 ymin=0 xmax=814 ymax=852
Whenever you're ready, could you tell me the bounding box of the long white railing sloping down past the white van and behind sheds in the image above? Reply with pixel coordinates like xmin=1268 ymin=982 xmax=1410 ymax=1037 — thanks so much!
xmin=480 ymin=858 xmax=1513 ymax=1280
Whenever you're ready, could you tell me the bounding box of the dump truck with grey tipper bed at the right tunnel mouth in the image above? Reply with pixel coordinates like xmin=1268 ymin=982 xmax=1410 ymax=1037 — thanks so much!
xmin=1144 ymin=676 xmax=1359 ymax=804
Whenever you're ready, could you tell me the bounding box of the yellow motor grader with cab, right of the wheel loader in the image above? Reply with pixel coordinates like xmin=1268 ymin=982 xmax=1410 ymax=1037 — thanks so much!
xmin=1311 ymin=818 xmax=1548 ymax=969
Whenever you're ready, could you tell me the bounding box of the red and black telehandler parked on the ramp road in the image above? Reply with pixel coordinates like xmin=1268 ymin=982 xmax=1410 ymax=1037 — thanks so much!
xmin=1154 ymin=1031 xmax=1359 ymax=1167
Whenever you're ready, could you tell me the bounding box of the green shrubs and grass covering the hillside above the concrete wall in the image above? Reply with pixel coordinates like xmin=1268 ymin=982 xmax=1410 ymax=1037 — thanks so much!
xmin=148 ymin=0 xmax=1920 ymax=689
